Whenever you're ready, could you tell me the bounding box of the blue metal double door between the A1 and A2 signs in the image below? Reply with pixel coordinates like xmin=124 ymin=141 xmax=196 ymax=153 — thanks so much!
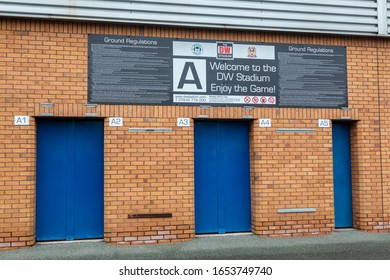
xmin=36 ymin=119 xmax=104 ymax=241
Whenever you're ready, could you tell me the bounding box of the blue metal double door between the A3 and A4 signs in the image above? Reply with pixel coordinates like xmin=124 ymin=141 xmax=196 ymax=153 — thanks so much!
xmin=195 ymin=122 xmax=251 ymax=234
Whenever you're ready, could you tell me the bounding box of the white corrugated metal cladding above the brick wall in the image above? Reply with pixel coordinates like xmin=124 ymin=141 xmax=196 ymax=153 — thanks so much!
xmin=0 ymin=0 xmax=390 ymax=35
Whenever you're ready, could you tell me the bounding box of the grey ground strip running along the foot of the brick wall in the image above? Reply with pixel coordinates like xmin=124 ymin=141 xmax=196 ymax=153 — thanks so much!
xmin=0 ymin=230 xmax=390 ymax=260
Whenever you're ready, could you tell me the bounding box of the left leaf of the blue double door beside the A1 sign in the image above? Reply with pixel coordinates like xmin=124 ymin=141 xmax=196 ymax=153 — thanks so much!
xmin=36 ymin=120 xmax=67 ymax=240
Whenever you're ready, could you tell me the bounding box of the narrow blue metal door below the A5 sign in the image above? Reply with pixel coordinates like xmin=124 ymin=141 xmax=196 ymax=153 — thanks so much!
xmin=332 ymin=122 xmax=353 ymax=228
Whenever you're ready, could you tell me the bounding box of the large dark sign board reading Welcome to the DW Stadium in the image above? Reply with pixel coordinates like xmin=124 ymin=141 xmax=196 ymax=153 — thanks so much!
xmin=88 ymin=35 xmax=348 ymax=108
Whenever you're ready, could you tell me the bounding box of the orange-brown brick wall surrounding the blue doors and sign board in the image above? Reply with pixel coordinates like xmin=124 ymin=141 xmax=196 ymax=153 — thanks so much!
xmin=0 ymin=19 xmax=390 ymax=248
